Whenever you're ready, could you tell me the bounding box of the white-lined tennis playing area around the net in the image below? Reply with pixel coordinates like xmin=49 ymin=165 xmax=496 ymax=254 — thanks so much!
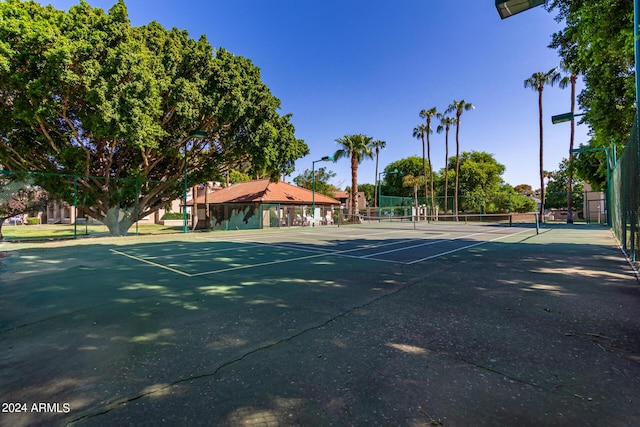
xmin=111 ymin=223 xmax=535 ymax=277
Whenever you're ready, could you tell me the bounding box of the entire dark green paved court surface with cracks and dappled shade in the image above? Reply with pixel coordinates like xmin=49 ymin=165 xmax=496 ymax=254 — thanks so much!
xmin=0 ymin=221 xmax=640 ymax=426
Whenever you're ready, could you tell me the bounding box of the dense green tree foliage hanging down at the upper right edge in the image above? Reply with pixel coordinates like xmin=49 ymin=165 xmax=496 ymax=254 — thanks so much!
xmin=547 ymin=0 xmax=635 ymax=188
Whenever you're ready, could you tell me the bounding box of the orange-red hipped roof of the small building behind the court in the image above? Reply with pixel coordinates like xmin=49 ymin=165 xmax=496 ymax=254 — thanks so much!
xmin=190 ymin=179 xmax=340 ymax=205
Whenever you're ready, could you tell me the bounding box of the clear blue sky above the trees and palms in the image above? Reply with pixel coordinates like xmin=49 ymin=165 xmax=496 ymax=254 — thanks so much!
xmin=43 ymin=0 xmax=588 ymax=188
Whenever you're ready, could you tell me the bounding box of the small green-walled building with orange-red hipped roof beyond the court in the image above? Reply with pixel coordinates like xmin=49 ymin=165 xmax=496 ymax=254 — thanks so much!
xmin=187 ymin=179 xmax=340 ymax=230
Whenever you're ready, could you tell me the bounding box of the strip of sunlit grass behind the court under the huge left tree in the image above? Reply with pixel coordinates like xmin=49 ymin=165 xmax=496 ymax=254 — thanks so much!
xmin=2 ymin=224 xmax=182 ymax=241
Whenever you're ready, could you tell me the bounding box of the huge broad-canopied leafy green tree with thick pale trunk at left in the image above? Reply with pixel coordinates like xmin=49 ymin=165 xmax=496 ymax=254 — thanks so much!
xmin=0 ymin=0 xmax=308 ymax=235
